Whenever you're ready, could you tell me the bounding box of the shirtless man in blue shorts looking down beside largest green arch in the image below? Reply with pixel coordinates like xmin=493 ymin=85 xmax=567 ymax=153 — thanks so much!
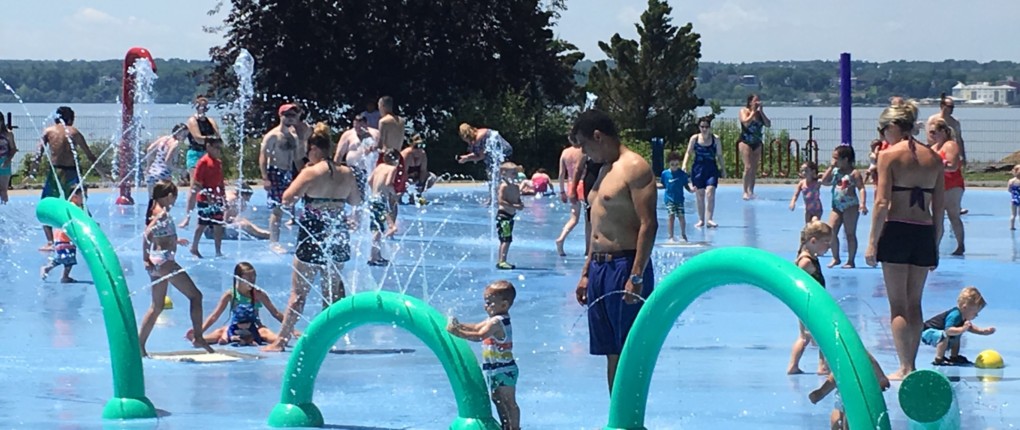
xmin=574 ymin=110 xmax=659 ymax=392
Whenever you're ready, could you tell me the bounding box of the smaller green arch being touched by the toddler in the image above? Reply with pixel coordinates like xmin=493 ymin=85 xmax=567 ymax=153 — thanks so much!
xmin=269 ymin=291 xmax=500 ymax=430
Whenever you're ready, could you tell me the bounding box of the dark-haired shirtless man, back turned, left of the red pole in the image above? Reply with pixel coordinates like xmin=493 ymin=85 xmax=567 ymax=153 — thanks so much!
xmin=32 ymin=106 xmax=98 ymax=251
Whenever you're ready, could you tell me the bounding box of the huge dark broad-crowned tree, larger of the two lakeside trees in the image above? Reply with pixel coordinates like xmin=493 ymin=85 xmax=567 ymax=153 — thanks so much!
xmin=209 ymin=0 xmax=576 ymax=129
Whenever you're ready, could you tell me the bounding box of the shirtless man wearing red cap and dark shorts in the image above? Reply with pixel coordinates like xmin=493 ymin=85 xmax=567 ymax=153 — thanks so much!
xmin=258 ymin=103 xmax=302 ymax=254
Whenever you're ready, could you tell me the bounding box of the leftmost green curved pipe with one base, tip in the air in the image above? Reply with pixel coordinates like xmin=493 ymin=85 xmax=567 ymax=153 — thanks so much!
xmin=36 ymin=198 xmax=156 ymax=420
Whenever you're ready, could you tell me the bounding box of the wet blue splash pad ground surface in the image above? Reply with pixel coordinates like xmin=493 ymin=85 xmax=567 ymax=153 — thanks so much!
xmin=0 ymin=186 xmax=1020 ymax=429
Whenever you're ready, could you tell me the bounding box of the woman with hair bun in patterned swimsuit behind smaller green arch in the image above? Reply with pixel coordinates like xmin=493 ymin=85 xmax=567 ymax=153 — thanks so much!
xmin=262 ymin=122 xmax=361 ymax=351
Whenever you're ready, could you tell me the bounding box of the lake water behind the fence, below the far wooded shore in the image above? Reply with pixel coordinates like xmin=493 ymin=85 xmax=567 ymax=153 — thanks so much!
xmin=0 ymin=103 xmax=1020 ymax=166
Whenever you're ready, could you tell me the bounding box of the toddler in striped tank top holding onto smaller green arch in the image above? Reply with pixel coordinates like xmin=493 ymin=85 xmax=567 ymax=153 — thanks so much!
xmin=447 ymin=280 xmax=520 ymax=430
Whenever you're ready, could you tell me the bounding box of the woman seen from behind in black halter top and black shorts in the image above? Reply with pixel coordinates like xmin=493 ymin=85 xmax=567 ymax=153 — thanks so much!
xmin=864 ymin=102 xmax=946 ymax=380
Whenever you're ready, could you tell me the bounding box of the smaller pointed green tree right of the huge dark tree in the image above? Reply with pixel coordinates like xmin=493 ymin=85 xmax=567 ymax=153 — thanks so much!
xmin=588 ymin=0 xmax=701 ymax=143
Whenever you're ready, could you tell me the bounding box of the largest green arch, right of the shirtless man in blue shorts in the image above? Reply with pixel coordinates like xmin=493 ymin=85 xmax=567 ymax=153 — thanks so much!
xmin=606 ymin=248 xmax=890 ymax=430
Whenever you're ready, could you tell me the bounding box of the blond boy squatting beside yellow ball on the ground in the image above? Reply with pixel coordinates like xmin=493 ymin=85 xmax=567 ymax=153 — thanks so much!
xmin=921 ymin=286 xmax=996 ymax=366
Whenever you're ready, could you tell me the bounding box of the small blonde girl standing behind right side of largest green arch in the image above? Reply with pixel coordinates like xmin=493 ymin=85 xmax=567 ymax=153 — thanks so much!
xmin=786 ymin=217 xmax=832 ymax=375
